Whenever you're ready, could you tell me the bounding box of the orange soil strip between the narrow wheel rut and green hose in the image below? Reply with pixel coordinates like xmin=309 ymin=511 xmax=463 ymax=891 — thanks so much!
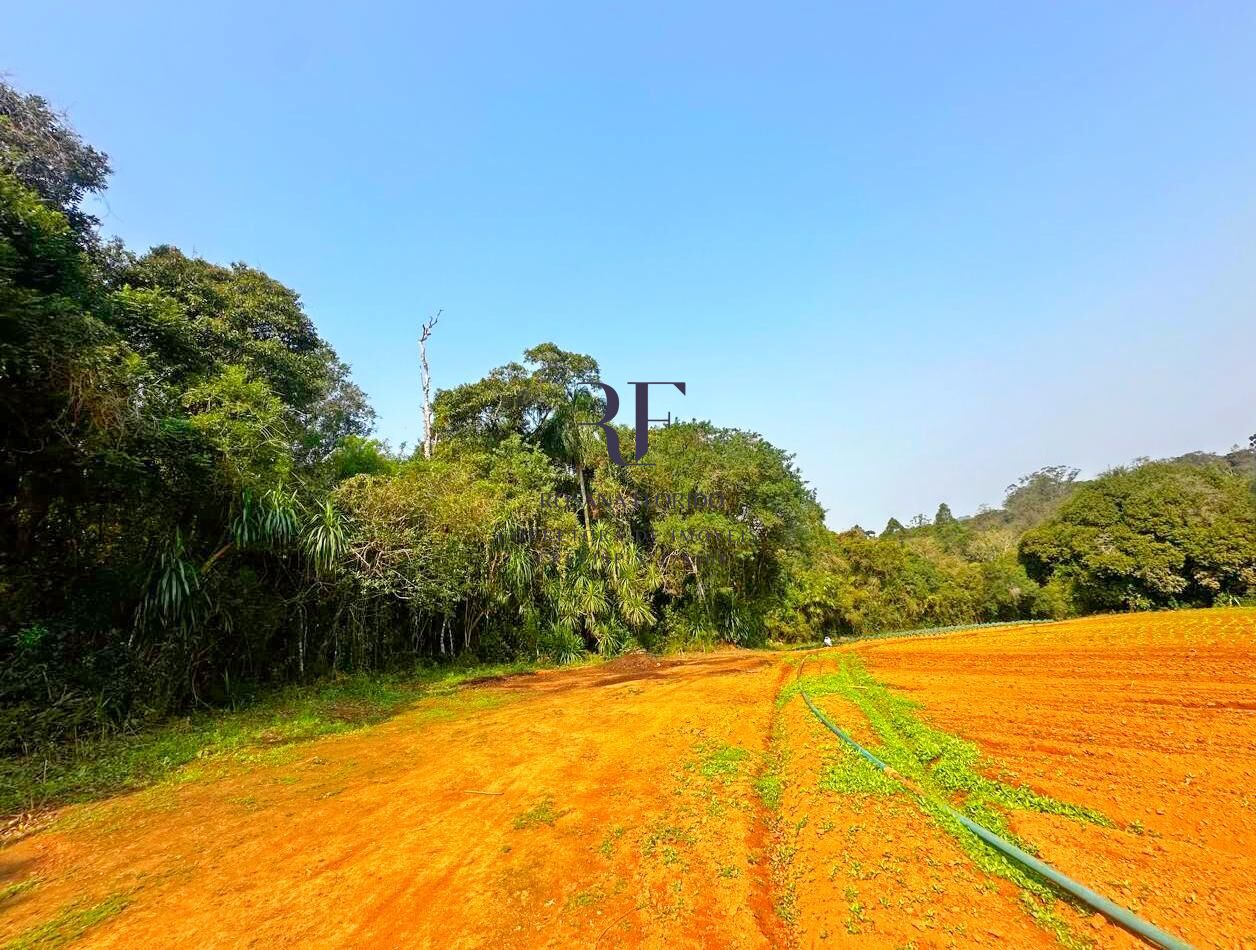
xmin=753 ymin=658 xmax=1090 ymax=947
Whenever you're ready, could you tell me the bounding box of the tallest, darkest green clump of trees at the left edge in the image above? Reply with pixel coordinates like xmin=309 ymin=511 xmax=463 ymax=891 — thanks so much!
xmin=0 ymin=85 xmax=371 ymax=748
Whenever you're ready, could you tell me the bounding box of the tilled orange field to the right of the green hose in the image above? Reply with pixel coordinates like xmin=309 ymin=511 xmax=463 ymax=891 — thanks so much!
xmin=853 ymin=609 xmax=1256 ymax=947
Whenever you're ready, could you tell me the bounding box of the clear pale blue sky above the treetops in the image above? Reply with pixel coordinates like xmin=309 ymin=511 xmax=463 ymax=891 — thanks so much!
xmin=0 ymin=0 xmax=1256 ymax=528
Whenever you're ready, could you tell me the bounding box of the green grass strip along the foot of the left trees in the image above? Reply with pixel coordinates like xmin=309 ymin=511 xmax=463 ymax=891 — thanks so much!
xmin=0 ymin=663 xmax=538 ymax=816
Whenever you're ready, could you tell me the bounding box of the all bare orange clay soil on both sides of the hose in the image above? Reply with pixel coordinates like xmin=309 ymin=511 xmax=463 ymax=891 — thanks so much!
xmin=0 ymin=611 xmax=1256 ymax=947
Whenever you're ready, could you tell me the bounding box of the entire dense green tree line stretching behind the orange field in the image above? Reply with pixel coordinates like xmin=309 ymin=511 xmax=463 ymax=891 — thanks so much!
xmin=7 ymin=84 xmax=1256 ymax=750
